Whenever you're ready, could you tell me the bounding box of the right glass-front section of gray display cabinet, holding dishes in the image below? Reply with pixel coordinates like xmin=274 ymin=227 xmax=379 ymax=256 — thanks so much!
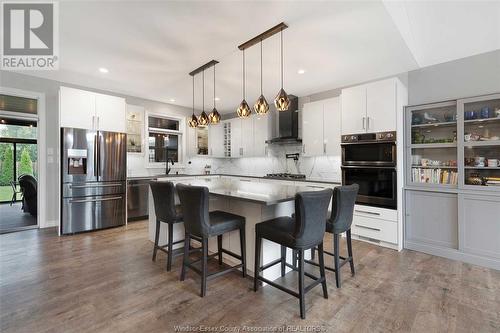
xmin=458 ymin=94 xmax=500 ymax=191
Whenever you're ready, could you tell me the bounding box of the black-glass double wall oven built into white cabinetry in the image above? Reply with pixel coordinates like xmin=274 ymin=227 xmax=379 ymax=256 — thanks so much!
xmin=342 ymin=132 xmax=397 ymax=209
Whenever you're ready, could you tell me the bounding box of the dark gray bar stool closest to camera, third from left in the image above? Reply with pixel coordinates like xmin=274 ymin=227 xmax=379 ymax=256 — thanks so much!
xmin=254 ymin=189 xmax=332 ymax=319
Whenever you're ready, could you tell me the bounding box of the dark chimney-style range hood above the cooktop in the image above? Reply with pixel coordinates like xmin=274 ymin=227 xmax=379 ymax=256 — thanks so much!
xmin=266 ymin=95 xmax=302 ymax=145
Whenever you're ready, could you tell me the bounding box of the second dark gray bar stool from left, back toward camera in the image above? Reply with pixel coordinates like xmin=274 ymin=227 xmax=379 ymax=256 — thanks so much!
xmin=176 ymin=184 xmax=246 ymax=297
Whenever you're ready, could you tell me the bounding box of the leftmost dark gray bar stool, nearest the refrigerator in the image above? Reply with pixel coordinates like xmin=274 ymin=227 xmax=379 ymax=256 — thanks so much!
xmin=149 ymin=180 xmax=184 ymax=271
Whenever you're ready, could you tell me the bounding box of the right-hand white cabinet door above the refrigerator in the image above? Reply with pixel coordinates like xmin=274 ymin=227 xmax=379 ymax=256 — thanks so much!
xmin=95 ymin=94 xmax=127 ymax=133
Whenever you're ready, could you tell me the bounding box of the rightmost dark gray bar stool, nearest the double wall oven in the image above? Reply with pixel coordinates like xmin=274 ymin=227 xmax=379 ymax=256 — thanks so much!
xmin=306 ymin=184 xmax=359 ymax=288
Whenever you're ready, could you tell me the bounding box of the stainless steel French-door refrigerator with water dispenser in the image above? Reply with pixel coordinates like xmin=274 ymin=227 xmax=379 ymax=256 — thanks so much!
xmin=61 ymin=128 xmax=127 ymax=234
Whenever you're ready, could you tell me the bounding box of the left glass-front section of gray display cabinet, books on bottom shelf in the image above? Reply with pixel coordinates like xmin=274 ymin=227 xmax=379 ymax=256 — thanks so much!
xmin=406 ymin=102 xmax=458 ymax=187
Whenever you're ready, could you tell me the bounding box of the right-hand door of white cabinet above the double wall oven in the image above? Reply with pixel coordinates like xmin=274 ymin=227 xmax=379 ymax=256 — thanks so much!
xmin=366 ymin=79 xmax=396 ymax=132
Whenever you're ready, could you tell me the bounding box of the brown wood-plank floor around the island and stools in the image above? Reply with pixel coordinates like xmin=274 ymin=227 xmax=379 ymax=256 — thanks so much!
xmin=0 ymin=222 xmax=500 ymax=332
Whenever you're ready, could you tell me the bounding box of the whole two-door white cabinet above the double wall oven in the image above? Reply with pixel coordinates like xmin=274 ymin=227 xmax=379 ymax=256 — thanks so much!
xmin=342 ymin=78 xmax=406 ymax=134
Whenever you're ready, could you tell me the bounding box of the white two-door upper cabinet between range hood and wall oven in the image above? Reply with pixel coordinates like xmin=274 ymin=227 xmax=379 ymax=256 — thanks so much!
xmin=302 ymin=97 xmax=342 ymax=156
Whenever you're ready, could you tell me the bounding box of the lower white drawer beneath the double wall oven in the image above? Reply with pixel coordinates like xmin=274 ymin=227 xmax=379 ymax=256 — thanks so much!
xmin=351 ymin=216 xmax=398 ymax=244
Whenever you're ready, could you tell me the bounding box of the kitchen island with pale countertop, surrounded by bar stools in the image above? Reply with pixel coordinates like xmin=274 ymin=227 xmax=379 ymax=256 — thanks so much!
xmin=149 ymin=175 xmax=336 ymax=280
